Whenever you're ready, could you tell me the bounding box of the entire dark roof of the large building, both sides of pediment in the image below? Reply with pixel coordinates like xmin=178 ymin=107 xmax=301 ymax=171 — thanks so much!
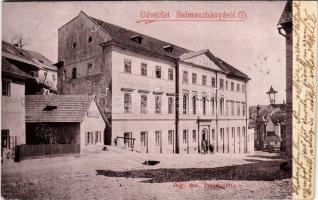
xmin=85 ymin=11 xmax=249 ymax=79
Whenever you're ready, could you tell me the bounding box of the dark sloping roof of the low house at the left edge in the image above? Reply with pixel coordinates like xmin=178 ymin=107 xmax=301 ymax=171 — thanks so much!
xmin=1 ymin=57 xmax=34 ymax=79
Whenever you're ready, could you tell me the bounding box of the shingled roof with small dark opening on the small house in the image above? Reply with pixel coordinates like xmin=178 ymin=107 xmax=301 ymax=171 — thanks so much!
xmin=25 ymin=95 xmax=94 ymax=123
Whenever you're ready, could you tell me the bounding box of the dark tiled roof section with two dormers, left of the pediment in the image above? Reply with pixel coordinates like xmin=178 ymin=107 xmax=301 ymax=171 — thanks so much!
xmin=90 ymin=17 xmax=191 ymax=58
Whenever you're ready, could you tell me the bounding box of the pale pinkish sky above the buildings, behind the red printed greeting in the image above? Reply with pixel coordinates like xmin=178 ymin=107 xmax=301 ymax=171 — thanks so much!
xmin=2 ymin=1 xmax=286 ymax=105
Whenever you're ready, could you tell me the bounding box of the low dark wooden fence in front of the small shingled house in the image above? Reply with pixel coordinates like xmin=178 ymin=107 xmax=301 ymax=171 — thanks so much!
xmin=15 ymin=144 xmax=80 ymax=162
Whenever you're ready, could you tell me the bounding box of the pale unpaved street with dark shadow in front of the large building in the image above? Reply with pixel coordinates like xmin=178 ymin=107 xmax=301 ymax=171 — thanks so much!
xmin=1 ymin=147 xmax=291 ymax=199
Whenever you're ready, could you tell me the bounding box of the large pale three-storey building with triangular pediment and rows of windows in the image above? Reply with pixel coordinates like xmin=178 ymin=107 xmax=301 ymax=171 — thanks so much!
xmin=58 ymin=12 xmax=253 ymax=153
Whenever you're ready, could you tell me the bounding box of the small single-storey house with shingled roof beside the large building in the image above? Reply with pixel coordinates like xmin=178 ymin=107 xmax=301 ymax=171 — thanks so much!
xmin=26 ymin=95 xmax=105 ymax=154
